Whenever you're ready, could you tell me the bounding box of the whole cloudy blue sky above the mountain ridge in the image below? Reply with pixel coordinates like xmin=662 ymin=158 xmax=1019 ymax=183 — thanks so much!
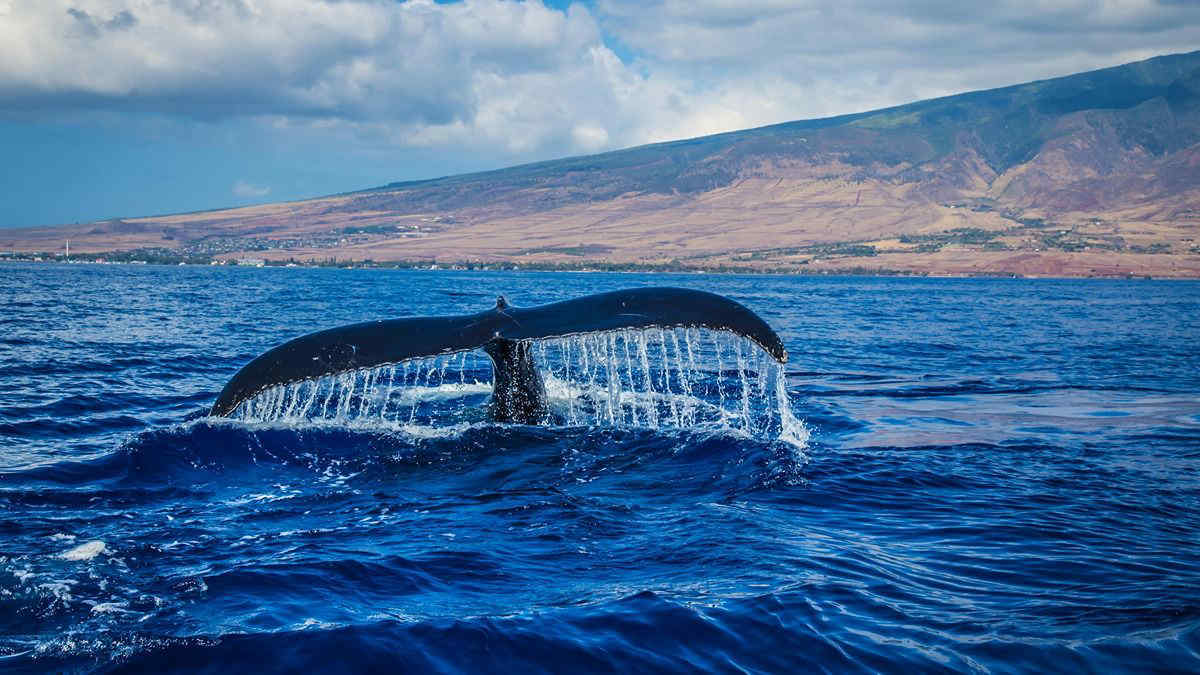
xmin=0 ymin=0 xmax=1200 ymax=227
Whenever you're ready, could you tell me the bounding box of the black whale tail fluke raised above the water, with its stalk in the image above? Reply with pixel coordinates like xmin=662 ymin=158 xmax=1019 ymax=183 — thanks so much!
xmin=210 ymin=288 xmax=787 ymax=424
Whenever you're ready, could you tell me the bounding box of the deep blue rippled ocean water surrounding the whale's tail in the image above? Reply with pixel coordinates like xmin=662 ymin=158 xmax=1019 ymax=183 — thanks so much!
xmin=0 ymin=264 xmax=1200 ymax=673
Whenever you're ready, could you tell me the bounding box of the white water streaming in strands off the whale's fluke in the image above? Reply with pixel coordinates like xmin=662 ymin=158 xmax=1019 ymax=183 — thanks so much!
xmin=225 ymin=328 xmax=808 ymax=447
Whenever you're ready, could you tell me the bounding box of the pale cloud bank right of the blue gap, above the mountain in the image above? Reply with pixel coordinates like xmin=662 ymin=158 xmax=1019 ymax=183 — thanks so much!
xmin=598 ymin=0 xmax=1200 ymax=135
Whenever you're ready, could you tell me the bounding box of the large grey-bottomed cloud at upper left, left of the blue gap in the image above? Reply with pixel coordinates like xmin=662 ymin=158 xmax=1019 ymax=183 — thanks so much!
xmin=0 ymin=0 xmax=580 ymax=125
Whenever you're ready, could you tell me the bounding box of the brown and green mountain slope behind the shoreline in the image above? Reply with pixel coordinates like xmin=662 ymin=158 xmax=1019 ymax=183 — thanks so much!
xmin=0 ymin=52 xmax=1200 ymax=276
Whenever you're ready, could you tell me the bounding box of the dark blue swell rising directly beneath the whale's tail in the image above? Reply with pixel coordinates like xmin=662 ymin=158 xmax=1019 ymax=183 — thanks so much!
xmin=0 ymin=418 xmax=804 ymax=498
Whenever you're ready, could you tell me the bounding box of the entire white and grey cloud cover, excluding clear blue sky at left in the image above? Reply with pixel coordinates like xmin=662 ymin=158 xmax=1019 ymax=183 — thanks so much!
xmin=0 ymin=0 xmax=1200 ymax=162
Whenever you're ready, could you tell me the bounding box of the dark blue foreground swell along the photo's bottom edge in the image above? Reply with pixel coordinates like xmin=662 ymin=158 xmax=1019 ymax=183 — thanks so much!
xmin=6 ymin=589 xmax=1200 ymax=673
